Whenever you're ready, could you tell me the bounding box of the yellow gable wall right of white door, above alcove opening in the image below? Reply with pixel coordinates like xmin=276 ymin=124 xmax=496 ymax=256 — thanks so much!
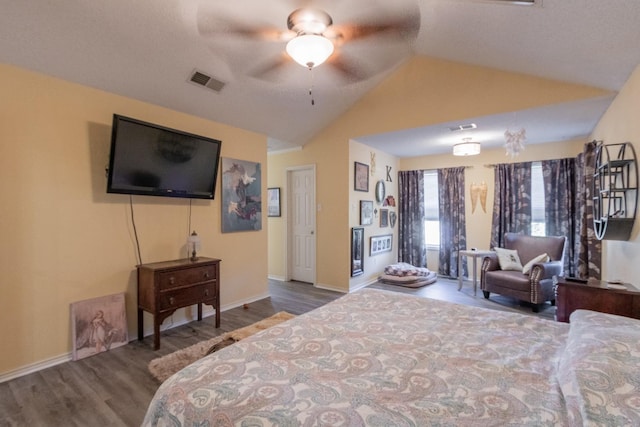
xmin=269 ymin=57 xmax=608 ymax=292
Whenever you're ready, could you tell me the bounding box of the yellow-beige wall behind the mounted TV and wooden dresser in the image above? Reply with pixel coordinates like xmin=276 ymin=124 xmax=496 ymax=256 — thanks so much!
xmin=0 ymin=65 xmax=267 ymax=376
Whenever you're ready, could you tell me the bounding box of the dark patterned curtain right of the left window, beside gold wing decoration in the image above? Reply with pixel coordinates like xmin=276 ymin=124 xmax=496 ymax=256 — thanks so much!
xmin=438 ymin=167 xmax=467 ymax=277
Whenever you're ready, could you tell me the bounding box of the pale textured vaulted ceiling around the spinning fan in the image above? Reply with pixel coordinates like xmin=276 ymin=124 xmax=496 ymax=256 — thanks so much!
xmin=0 ymin=0 xmax=640 ymax=155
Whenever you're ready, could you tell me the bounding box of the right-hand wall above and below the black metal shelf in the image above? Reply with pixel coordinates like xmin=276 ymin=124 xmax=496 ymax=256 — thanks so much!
xmin=593 ymin=66 xmax=640 ymax=285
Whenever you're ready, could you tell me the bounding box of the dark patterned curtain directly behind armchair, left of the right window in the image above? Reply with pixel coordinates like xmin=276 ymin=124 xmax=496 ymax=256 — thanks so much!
xmin=490 ymin=162 xmax=531 ymax=248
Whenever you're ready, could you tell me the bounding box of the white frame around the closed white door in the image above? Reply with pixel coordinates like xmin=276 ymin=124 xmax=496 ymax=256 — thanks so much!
xmin=281 ymin=164 xmax=318 ymax=286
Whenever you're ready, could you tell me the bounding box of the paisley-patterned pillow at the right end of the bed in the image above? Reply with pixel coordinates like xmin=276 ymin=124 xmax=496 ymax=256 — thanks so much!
xmin=558 ymin=310 xmax=640 ymax=425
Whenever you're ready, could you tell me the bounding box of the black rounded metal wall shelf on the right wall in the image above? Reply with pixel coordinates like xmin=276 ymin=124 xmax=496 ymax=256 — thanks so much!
xmin=593 ymin=142 xmax=638 ymax=240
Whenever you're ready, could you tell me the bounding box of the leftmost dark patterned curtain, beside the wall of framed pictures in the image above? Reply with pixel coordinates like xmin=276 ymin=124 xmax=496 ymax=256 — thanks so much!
xmin=398 ymin=170 xmax=427 ymax=267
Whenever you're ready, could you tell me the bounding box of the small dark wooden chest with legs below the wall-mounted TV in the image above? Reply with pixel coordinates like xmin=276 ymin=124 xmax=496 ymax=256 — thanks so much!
xmin=138 ymin=257 xmax=220 ymax=350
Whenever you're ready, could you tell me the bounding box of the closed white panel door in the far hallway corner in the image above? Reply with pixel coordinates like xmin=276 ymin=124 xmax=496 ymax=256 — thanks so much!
xmin=287 ymin=167 xmax=316 ymax=284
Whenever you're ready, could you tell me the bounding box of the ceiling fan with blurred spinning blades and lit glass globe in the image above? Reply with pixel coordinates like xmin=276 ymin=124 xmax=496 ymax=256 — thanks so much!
xmin=198 ymin=0 xmax=420 ymax=83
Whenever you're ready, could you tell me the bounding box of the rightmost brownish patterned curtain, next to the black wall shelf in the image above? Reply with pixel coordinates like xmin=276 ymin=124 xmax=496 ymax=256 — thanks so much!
xmin=572 ymin=141 xmax=602 ymax=279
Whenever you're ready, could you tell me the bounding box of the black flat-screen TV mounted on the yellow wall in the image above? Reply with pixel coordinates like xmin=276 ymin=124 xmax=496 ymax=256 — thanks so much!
xmin=107 ymin=114 xmax=222 ymax=199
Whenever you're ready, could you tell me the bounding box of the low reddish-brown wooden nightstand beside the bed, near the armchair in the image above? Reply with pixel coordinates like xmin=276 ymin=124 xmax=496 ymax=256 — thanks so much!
xmin=556 ymin=277 xmax=640 ymax=322
